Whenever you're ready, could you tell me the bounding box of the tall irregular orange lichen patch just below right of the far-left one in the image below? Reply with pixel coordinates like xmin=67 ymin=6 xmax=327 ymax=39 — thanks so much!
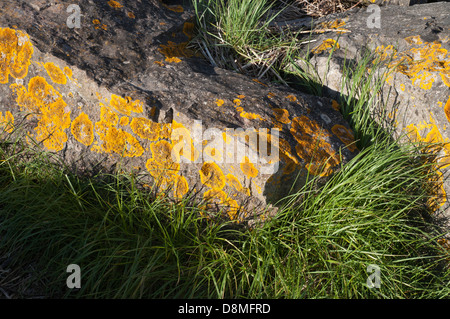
xmin=11 ymin=76 xmax=70 ymax=151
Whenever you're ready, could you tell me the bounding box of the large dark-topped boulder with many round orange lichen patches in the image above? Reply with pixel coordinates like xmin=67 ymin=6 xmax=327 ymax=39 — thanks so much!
xmin=0 ymin=0 xmax=358 ymax=225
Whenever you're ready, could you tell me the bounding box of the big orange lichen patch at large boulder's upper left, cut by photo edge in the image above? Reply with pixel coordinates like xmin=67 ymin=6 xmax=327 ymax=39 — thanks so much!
xmin=0 ymin=28 xmax=33 ymax=84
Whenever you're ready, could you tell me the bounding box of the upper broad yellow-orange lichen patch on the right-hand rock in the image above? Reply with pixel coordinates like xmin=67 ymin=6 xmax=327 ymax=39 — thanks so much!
xmin=374 ymin=36 xmax=450 ymax=90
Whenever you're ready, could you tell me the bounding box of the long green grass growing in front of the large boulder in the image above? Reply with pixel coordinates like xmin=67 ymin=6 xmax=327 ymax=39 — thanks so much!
xmin=0 ymin=1 xmax=450 ymax=298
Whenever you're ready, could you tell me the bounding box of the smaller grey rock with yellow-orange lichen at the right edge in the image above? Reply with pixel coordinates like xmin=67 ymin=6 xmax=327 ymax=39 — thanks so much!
xmin=290 ymin=2 xmax=450 ymax=221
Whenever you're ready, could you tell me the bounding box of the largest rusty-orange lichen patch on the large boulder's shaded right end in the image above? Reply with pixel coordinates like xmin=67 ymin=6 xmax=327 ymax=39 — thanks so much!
xmin=291 ymin=116 xmax=339 ymax=176
